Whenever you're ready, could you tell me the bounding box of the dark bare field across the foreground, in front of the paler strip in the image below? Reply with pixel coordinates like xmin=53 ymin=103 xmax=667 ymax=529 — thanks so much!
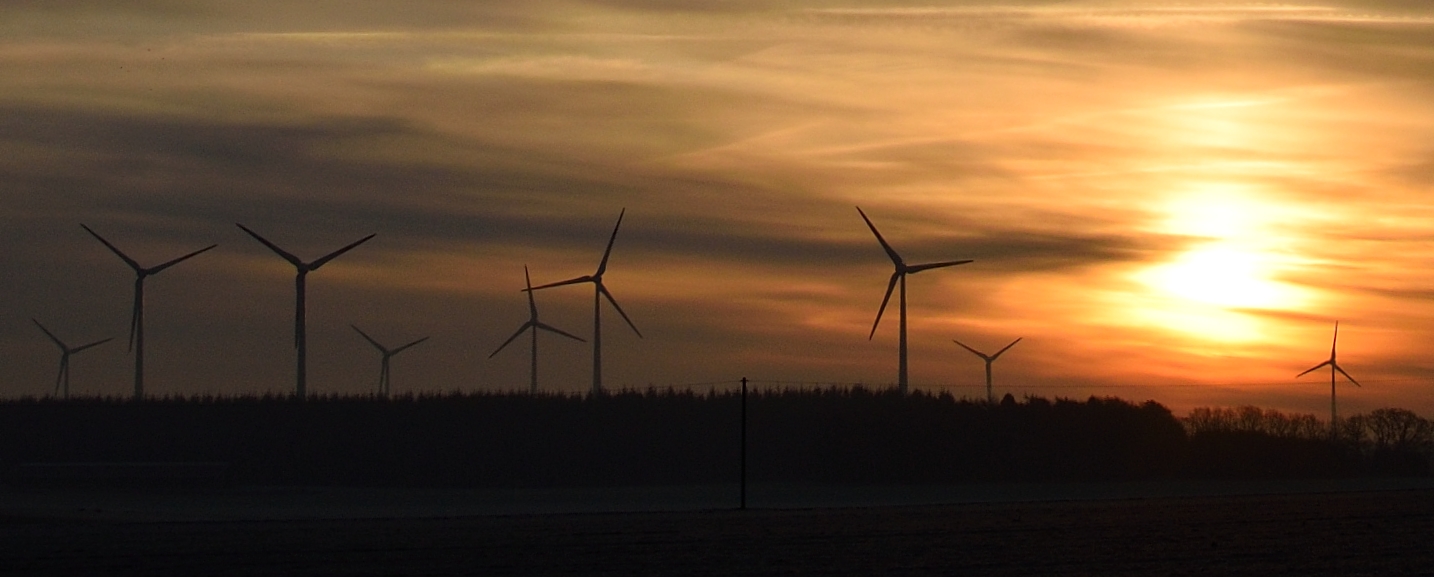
xmin=0 ymin=489 xmax=1434 ymax=576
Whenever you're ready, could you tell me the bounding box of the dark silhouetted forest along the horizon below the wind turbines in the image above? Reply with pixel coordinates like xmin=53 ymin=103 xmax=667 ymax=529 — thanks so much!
xmin=0 ymin=388 xmax=1434 ymax=487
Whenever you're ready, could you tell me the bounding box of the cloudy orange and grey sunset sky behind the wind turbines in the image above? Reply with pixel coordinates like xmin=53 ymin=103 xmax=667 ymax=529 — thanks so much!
xmin=0 ymin=0 xmax=1434 ymax=416
